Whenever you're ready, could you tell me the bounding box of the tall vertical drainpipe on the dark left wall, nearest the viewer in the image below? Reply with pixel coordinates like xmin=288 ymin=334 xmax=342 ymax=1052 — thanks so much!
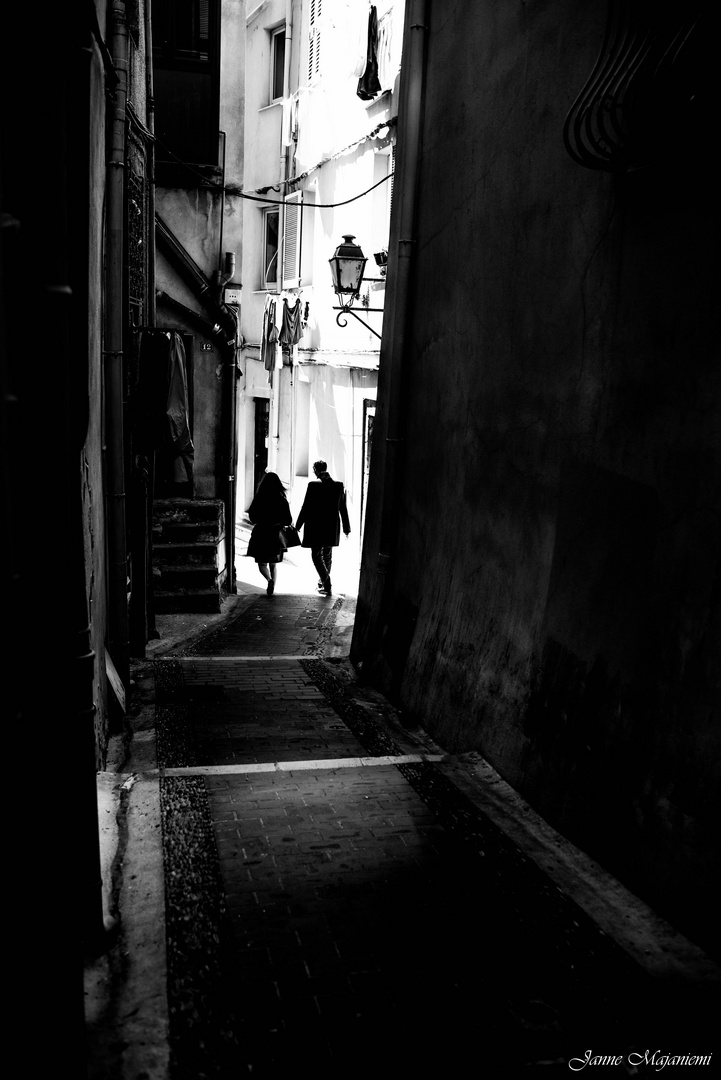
xmin=104 ymin=0 xmax=130 ymax=687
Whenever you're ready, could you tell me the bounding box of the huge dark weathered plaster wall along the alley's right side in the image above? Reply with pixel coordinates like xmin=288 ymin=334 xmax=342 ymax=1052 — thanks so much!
xmin=354 ymin=0 xmax=721 ymax=939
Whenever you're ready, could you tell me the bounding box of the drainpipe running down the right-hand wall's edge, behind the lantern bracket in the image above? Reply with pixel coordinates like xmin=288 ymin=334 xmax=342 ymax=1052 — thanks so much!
xmin=377 ymin=0 xmax=427 ymax=575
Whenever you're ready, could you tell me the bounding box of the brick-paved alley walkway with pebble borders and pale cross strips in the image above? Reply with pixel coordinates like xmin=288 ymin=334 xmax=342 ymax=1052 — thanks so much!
xmin=154 ymin=595 xmax=706 ymax=1080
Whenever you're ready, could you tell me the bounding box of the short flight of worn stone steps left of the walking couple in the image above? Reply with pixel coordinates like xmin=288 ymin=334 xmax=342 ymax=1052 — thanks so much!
xmin=152 ymin=499 xmax=228 ymax=615
